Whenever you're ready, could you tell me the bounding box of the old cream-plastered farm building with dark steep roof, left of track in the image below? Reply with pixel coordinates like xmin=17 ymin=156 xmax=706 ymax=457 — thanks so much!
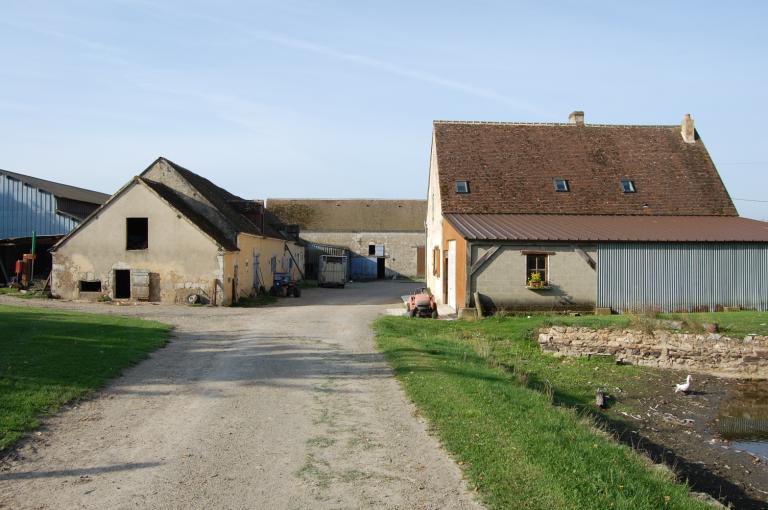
xmin=52 ymin=158 xmax=303 ymax=305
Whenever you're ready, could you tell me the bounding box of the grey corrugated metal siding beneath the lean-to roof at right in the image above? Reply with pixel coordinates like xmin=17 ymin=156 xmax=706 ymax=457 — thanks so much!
xmin=597 ymin=243 xmax=768 ymax=312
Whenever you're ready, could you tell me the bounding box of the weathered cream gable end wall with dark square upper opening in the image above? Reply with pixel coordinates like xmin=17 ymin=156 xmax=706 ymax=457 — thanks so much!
xmin=51 ymin=182 xmax=224 ymax=304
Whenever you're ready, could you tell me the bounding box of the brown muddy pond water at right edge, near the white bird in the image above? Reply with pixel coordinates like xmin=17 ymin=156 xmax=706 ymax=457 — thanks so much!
xmin=717 ymin=381 xmax=768 ymax=461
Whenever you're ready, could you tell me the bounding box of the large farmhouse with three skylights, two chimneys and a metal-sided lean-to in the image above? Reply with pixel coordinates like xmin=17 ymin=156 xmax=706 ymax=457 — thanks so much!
xmin=427 ymin=112 xmax=768 ymax=311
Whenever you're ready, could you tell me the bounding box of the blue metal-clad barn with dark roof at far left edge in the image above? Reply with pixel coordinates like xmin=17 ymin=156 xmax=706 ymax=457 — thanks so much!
xmin=0 ymin=169 xmax=109 ymax=284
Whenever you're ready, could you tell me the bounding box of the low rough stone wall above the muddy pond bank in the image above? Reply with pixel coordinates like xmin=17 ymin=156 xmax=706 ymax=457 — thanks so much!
xmin=539 ymin=327 xmax=768 ymax=379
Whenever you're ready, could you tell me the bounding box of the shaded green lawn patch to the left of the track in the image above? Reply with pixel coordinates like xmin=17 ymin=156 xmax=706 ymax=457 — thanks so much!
xmin=0 ymin=305 xmax=170 ymax=450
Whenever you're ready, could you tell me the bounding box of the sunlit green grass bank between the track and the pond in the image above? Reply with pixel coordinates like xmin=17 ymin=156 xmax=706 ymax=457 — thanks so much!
xmin=375 ymin=314 xmax=724 ymax=510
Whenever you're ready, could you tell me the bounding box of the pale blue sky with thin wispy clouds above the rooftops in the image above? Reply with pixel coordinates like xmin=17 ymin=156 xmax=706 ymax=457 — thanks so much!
xmin=0 ymin=0 xmax=768 ymax=220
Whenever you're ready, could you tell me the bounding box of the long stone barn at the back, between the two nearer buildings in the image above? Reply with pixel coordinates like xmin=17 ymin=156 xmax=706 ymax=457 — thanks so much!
xmin=267 ymin=198 xmax=427 ymax=280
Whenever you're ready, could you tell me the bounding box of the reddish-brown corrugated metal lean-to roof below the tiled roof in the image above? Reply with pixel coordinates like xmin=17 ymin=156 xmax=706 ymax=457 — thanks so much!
xmin=445 ymin=214 xmax=768 ymax=242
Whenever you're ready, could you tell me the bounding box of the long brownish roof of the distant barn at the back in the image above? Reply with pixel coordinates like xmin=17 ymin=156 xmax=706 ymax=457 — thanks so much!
xmin=267 ymin=198 xmax=427 ymax=232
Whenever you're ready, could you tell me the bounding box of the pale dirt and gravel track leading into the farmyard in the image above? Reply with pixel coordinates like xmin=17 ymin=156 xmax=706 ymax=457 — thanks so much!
xmin=0 ymin=282 xmax=479 ymax=509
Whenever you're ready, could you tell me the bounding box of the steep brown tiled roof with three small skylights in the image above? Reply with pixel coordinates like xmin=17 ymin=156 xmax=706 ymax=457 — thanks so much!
xmin=434 ymin=121 xmax=737 ymax=216
